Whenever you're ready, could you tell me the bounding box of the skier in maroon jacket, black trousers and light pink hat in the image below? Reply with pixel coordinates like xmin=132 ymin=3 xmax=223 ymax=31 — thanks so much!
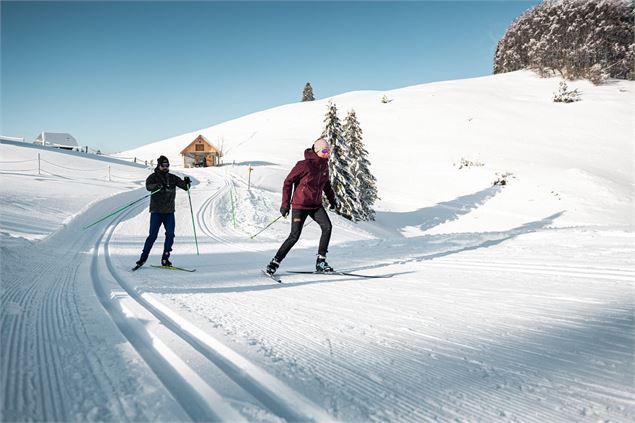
xmin=267 ymin=138 xmax=336 ymax=275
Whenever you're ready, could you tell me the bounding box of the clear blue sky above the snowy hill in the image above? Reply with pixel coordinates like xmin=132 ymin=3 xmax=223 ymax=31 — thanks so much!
xmin=0 ymin=1 xmax=538 ymax=152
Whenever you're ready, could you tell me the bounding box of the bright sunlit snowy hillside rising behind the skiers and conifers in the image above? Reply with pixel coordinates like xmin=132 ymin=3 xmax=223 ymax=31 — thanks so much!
xmin=122 ymin=71 xmax=635 ymax=232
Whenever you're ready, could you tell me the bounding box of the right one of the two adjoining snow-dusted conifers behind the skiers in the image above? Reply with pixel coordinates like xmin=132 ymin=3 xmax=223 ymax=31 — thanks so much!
xmin=343 ymin=110 xmax=377 ymax=221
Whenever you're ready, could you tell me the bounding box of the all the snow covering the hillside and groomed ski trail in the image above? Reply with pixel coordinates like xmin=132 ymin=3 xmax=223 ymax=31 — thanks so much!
xmin=0 ymin=72 xmax=635 ymax=422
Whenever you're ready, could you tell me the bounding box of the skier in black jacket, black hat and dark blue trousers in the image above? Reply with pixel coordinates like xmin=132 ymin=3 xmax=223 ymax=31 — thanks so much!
xmin=134 ymin=156 xmax=191 ymax=270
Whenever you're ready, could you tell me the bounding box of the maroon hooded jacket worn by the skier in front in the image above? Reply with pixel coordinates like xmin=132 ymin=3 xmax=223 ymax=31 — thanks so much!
xmin=282 ymin=148 xmax=335 ymax=210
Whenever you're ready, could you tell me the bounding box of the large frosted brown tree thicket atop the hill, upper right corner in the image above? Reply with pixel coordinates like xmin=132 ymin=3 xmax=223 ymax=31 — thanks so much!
xmin=494 ymin=0 xmax=635 ymax=83
